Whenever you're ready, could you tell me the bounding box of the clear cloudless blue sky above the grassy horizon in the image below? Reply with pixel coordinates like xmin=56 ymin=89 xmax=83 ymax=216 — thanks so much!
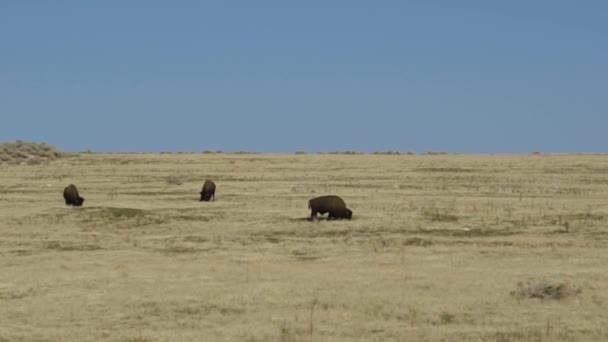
xmin=0 ymin=0 xmax=608 ymax=153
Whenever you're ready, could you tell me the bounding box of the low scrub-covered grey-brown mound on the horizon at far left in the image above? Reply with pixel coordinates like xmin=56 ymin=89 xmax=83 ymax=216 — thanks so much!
xmin=0 ymin=140 xmax=75 ymax=164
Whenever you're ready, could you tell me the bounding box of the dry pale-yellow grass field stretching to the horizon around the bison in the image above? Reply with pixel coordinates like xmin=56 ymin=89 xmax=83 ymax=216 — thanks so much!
xmin=0 ymin=154 xmax=608 ymax=342
